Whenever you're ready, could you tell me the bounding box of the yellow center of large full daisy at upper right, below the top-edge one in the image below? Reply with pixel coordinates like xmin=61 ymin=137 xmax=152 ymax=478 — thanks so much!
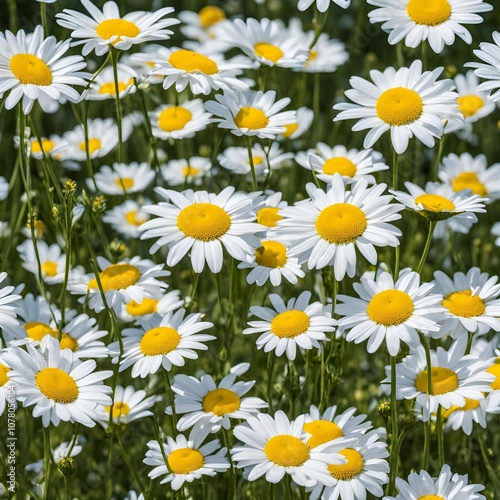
xmin=375 ymin=86 xmax=424 ymax=127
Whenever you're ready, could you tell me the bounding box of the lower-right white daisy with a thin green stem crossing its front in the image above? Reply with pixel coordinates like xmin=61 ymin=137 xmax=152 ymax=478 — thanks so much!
xmin=382 ymin=337 xmax=495 ymax=421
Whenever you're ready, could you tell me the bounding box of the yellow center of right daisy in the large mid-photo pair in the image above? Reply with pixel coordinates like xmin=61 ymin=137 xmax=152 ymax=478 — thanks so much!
xmin=316 ymin=203 xmax=368 ymax=245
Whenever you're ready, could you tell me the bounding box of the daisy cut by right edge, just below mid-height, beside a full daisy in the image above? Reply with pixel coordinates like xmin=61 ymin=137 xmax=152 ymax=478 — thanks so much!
xmin=433 ymin=267 xmax=500 ymax=338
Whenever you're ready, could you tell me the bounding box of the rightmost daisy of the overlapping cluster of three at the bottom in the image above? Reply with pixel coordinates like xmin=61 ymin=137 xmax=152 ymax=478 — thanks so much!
xmin=309 ymin=431 xmax=389 ymax=500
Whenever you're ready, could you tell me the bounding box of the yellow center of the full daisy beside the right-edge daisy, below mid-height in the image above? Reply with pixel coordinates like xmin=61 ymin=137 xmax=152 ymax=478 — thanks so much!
xmin=366 ymin=290 xmax=415 ymax=326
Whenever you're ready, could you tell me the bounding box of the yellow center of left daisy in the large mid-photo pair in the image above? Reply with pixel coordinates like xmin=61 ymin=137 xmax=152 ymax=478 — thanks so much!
xmin=177 ymin=203 xmax=231 ymax=241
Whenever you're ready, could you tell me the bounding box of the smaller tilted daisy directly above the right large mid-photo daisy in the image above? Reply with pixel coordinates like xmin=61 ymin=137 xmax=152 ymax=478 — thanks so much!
xmin=295 ymin=142 xmax=389 ymax=184
